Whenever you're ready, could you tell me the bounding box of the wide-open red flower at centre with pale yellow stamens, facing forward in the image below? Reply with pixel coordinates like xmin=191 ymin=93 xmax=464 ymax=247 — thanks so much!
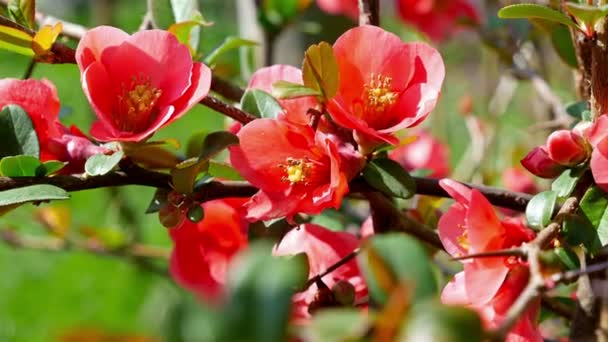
xmin=230 ymin=119 xmax=360 ymax=220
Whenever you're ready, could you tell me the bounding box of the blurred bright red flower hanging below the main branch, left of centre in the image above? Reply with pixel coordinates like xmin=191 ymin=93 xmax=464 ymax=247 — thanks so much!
xmin=169 ymin=200 xmax=247 ymax=299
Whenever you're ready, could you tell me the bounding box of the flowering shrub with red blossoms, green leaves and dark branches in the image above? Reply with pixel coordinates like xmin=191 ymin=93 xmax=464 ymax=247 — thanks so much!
xmin=0 ymin=0 xmax=608 ymax=341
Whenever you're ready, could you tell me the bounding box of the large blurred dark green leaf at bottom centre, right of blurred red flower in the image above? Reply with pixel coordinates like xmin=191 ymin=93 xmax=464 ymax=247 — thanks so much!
xmin=218 ymin=241 xmax=309 ymax=342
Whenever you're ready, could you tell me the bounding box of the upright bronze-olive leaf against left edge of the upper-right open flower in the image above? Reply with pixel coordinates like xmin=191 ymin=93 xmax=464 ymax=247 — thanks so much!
xmin=302 ymin=42 xmax=339 ymax=100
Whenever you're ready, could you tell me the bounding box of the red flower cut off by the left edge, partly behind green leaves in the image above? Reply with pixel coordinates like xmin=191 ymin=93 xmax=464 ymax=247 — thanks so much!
xmin=0 ymin=79 xmax=106 ymax=173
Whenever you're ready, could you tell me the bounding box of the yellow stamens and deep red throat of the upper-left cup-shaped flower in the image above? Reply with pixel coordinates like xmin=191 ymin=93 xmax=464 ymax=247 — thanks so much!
xmin=114 ymin=75 xmax=162 ymax=132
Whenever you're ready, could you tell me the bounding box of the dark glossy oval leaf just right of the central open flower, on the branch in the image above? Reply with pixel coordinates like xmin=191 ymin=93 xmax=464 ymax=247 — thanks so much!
xmin=363 ymin=158 xmax=416 ymax=198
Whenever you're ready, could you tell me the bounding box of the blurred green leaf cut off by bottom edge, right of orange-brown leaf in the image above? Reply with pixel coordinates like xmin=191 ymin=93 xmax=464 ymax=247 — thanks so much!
xmin=398 ymin=301 xmax=485 ymax=342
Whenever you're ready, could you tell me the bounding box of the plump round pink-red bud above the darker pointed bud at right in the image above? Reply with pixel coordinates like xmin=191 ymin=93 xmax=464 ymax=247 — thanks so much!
xmin=547 ymin=130 xmax=589 ymax=166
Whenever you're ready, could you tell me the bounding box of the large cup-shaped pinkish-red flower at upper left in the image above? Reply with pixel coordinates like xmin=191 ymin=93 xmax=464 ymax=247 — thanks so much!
xmin=76 ymin=26 xmax=211 ymax=141
